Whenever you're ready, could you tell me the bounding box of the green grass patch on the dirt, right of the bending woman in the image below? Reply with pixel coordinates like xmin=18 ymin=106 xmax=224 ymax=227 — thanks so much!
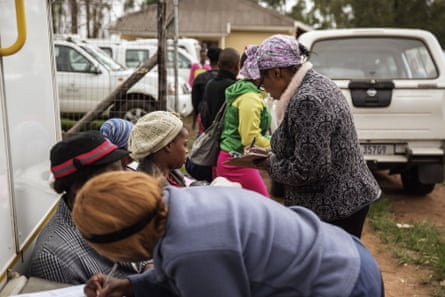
xmin=367 ymin=195 xmax=445 ymax=297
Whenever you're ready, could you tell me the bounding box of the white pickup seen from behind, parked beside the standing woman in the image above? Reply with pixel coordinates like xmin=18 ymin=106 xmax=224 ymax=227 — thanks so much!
xmin=299 ymin=28 xmax=445 ymax=195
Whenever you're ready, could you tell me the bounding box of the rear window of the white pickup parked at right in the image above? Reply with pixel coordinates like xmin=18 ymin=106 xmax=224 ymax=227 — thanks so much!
xmin=311 ymin=37 xmax=438 ymax=79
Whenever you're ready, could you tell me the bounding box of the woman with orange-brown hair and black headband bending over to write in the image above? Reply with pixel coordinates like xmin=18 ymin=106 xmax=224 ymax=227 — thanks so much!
xmin=73 ymin=171 xmax=383 ymax=297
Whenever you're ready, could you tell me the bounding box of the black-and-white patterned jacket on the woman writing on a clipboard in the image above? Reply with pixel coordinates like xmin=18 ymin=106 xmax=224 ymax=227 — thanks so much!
xmin=269 ymin=70 xmax=381 ymax=221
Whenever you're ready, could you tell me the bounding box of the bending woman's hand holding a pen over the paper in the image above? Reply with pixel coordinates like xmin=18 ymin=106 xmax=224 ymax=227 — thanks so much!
xmin=83 ymin=274 xmax=134 ymax=297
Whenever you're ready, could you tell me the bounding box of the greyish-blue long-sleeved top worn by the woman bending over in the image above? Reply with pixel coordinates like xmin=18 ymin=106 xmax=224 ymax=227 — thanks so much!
xmin=129 ymin=186 xmax=378 ymax=297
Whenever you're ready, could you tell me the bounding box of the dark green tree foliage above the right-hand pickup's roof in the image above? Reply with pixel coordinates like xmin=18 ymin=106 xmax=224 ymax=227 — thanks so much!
xmin=289 ymin=0 xmax=445 ymax=47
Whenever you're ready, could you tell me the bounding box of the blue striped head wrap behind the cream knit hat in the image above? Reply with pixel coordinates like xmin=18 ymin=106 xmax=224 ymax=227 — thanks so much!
xmin=100 ymin=118 xmax=133 ymax=148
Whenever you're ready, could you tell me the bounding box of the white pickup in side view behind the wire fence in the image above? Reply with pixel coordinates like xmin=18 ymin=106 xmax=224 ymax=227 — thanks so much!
xmin=54 ymin=40 xmax=193 ymax=122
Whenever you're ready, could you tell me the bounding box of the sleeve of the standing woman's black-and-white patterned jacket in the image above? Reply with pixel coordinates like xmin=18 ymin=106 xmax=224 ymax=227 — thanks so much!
xmin=269 ymin=95 xmax=332 ymax=186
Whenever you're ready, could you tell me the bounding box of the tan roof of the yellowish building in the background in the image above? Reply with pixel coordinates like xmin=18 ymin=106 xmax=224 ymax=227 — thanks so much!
xmin=110 ymin=0 xmax=295 ymax=37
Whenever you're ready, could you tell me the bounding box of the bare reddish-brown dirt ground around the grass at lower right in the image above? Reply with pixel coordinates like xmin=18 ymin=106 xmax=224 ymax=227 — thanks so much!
xmin=362 ymin=173 xmax=445 ymax=297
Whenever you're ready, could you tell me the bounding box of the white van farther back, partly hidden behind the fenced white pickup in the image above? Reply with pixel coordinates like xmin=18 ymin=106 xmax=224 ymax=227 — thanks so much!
xmin=88 ymin=39 xmax=198 ymax=82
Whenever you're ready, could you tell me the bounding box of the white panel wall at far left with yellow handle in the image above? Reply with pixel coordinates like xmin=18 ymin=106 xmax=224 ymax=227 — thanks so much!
xmin=0 ymin=0 xmax=60 ymax=287
